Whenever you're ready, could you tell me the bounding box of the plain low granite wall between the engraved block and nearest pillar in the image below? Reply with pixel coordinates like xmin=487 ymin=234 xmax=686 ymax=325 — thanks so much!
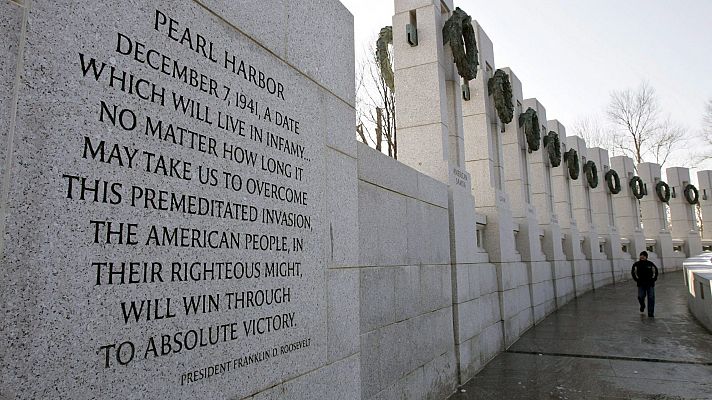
xmin=357 ymin=144 xmax=457 ymax=399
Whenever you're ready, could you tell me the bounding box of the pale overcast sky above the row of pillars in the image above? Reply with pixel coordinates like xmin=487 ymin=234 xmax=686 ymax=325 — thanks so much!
xmin=341 ymin=0 xmax=712 ymax=168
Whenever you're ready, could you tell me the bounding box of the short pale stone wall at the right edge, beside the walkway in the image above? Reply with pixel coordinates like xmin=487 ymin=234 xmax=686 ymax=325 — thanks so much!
xmin=683 ymin=253 xmax=712 ymax=331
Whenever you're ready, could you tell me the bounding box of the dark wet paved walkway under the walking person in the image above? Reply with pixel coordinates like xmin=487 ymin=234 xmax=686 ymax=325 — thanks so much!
xmin=450 ymin=272 xmax=712 ymax=400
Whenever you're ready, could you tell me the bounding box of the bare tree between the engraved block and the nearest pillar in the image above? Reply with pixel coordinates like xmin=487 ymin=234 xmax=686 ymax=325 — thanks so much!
xmin=356 ymin=28 xmax=398 ymax=158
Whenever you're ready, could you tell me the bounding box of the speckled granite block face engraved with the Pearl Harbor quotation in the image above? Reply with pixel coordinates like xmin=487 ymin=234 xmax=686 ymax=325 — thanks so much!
xmin=0 ymin=1 xmax=356 ymax=399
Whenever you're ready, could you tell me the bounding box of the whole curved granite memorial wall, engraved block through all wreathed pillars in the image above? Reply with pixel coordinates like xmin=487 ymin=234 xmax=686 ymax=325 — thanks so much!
xmin=0 ymin=0 xmax=710 ymax=399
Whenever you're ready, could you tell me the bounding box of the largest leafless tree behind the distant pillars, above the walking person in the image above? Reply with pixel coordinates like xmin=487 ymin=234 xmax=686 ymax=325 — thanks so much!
xmin=607 ymin=82 xmax=685 ymax=165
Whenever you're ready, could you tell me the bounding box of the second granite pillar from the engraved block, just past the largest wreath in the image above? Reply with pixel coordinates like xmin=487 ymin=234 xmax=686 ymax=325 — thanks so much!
xmin=462 ymin=22 xmax=532 ymax=346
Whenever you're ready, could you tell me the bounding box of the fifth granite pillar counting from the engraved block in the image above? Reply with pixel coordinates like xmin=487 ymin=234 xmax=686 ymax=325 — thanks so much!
xmin=547 ymin=120 xmax=593 ymax=298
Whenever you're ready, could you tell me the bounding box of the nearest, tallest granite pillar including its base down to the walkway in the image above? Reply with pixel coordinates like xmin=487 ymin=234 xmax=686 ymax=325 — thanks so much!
xmin=393 ymin=0 xmax=504 ymax=385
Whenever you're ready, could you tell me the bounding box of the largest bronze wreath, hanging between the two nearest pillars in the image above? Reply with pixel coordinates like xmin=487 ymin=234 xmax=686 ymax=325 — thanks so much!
xmin=443 ymin=7 xmax=479 ymax=81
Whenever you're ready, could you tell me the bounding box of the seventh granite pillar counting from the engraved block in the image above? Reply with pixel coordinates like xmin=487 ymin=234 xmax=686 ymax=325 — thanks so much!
xmin=584 ymin=147 xmax=630 ymax=282
